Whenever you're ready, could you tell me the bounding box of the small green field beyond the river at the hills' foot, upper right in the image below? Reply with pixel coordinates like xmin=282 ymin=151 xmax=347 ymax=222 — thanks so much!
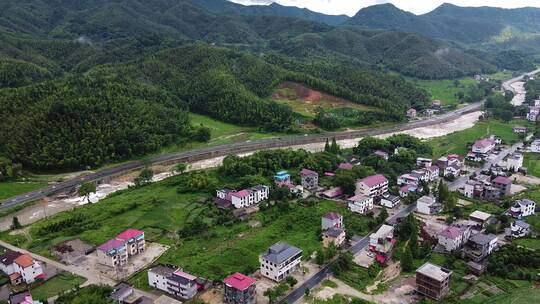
xmin=413 ymin=77 xmax=476 ymax=106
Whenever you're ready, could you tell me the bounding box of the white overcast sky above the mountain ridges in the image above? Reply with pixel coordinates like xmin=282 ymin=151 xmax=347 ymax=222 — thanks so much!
xmin=230 ymin=0 xmax=540 ymax=16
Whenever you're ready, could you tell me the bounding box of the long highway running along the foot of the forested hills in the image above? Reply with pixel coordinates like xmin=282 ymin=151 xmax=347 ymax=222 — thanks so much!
xmin=0 ymin=102 xmax=483 ymax=209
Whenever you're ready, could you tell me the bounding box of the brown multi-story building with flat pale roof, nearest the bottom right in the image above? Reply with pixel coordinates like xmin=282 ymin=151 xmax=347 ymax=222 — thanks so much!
xmin=416 ymin=263 xmax=452 ymax=301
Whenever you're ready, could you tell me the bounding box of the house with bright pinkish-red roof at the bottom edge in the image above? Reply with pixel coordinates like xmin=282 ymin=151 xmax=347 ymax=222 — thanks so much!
xmin=223 ymin=272 xmax=257 ymax=304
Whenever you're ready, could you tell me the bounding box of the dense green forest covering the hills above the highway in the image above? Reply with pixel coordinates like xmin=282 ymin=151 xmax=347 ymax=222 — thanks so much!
xmin=0 ymin=0 xmax=532 ymax=169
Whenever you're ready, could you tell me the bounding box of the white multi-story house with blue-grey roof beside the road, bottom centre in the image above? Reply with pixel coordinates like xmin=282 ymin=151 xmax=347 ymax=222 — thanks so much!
xmin=259 ymin=242 xmax=302 ymax=282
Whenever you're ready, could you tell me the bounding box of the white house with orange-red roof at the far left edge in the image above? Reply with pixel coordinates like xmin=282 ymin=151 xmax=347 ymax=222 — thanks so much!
xmin=0 ymin=250 xmax=45 ymax=285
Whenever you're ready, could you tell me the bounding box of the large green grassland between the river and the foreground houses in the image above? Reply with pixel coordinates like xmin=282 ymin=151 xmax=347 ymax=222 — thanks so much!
xmin=2 ymin=169 xmax=372 ymax=282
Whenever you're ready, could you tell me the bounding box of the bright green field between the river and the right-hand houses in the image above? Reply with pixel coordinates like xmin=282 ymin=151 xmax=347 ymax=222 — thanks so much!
xmin=429 ymin=119 xmax=529 ymax=157
